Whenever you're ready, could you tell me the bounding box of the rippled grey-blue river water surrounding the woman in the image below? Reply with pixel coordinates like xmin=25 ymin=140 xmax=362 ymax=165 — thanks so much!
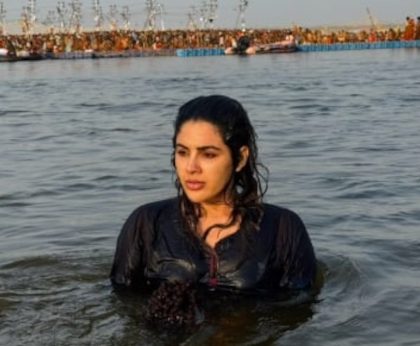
xmin=0 ymin=49 xmax=420 ymax=346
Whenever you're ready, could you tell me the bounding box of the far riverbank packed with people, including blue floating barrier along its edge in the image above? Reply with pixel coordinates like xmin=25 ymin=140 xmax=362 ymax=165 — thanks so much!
xmin=0 ymin=23 xmax=420 ymax=61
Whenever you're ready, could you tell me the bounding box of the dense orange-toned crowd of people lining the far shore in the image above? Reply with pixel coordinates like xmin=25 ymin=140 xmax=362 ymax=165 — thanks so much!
xmin=0 ymin=17 xmax=420 ymax=54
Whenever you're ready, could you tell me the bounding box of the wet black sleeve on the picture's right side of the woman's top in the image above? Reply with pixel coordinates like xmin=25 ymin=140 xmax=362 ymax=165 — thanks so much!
xmin=274 ymin=211 xmax=316 ymax=289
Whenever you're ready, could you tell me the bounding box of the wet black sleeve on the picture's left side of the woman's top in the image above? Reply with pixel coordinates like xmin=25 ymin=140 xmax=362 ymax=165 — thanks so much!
xmin=110 ymin=208 xmax=150 ymax=287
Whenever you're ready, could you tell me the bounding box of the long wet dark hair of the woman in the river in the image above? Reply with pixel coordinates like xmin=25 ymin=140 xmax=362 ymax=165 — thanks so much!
xmin=172 ymin=95 xmax=268 ymax=246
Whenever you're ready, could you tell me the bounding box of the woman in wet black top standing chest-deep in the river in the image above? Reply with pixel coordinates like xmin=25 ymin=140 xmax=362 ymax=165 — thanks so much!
xmin=111 ymin=95 xmax=316 ymax=294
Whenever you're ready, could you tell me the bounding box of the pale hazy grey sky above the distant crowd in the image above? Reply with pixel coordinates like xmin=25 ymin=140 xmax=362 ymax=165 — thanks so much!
xmin=0 ymin=0 xmax=420 ymax=29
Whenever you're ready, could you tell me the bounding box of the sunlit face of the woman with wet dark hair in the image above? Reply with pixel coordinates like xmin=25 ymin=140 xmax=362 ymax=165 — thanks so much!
xmin=175 ymin=120 xmax=234 ymax=205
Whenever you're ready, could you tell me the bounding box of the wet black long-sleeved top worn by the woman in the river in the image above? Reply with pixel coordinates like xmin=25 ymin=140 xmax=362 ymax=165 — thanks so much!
xmin=111 ymin=198 xmax=316 ymax=291
